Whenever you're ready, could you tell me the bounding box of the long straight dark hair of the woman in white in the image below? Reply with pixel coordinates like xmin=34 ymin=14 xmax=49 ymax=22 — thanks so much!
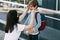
xmin=5 ymin=10 xmax=18 ymax=33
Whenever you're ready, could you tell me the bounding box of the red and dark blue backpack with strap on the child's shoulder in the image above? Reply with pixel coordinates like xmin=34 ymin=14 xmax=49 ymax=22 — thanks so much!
xmin=35 ymin=12 xmax=47 ymax=31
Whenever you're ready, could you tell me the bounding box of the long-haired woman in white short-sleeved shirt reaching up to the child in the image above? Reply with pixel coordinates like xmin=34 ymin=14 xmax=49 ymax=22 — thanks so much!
xmin=4 ymin=9 xmax=35 ymax=40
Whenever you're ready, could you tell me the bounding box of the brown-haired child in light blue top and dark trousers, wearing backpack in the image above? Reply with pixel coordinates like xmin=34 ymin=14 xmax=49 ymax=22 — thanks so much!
xmin=25 ymin=1 xmax=41 ymax=40
